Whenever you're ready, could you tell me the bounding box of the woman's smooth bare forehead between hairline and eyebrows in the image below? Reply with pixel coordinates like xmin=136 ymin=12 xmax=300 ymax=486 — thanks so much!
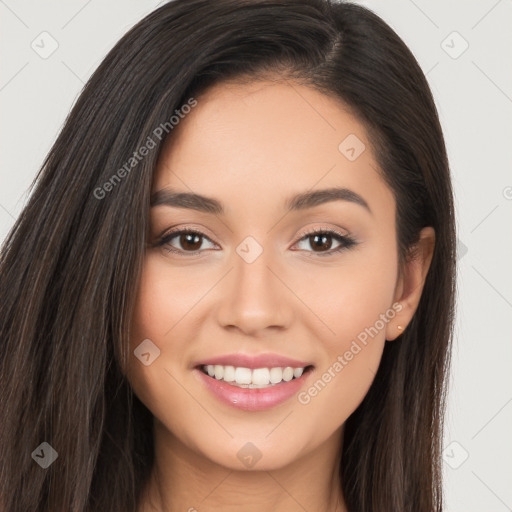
xmin=153 ymin=81 xmax=394 ymax=219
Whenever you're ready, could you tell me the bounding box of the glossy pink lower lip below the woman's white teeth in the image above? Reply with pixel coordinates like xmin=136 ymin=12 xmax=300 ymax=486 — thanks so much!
xmin=194 ymin=368 xmax=311 ymax=411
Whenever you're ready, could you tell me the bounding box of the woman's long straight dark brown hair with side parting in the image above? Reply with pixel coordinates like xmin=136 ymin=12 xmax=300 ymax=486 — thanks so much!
xmin=0 ymin=0 xmax=456 ymax=512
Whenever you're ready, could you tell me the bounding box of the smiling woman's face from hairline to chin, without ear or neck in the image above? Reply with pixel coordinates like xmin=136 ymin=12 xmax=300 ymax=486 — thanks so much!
xmin=128 ymin=82 xmax=426 ymax=469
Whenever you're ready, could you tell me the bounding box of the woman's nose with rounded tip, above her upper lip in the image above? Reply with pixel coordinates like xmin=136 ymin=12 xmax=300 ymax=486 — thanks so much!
xmin=217 ymin=244 xmax=293 ymax=336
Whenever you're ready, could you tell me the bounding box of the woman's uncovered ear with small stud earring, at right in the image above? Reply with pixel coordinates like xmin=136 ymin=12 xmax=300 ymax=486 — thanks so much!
xmin=386 ymin=226 xmax=435 ymax=341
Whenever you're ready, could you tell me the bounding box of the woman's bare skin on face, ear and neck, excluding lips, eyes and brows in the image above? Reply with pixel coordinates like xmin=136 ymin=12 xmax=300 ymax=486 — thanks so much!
xmin=127 ymin=80 xmax=435 ymax=512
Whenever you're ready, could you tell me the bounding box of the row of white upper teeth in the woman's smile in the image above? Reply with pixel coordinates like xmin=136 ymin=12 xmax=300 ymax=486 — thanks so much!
xmin=202 ymin=364 xmax=304 ymax=388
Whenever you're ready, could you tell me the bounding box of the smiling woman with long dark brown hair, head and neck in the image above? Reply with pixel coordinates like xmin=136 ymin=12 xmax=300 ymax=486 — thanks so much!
xmin=0 ymin=0 xmax=455 ymax=512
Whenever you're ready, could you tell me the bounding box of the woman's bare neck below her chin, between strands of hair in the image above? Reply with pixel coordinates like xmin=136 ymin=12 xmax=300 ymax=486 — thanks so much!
xmin=139 ymin=420 xmax=347 ymax=512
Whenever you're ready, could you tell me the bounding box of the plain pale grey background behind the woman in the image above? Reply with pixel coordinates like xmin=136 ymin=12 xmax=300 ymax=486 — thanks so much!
xmin=0 ymin=0 xmax=512 ymax=512
